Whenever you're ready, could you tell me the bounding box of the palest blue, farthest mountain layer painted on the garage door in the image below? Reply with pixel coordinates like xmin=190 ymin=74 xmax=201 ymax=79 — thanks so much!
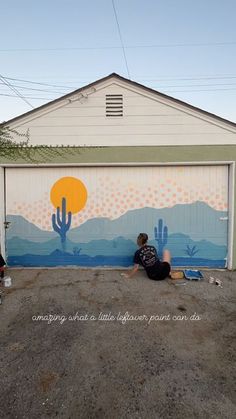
xmin=7 ymin=201 xmax=227 ymax=246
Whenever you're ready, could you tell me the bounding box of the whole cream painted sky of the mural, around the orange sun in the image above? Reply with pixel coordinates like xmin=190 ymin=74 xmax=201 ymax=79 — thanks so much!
xmin=7 ymin=166 xmax=228 ymax=230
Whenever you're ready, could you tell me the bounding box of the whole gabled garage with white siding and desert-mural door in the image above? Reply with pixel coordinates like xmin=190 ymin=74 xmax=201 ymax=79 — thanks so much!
xmin=0 ymin=73 xmax=236 ymax=269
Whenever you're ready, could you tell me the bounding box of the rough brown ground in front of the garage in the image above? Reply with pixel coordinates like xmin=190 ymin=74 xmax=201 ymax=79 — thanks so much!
xmin=0 ymin=269 xmax=236 ymax=419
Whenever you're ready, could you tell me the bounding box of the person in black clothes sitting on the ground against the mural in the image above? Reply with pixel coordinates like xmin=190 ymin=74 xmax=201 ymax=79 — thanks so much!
xmin=122 ymin=233 xmax=171 ymax=281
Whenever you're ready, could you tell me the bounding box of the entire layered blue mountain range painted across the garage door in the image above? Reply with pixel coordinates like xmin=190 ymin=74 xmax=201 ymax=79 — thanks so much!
xmin=7 ymin=202 xmax=227 ymax=267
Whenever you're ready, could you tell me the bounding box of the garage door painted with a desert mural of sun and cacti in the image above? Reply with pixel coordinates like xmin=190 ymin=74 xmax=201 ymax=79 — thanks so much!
xmin=6 ymin=165 xmax=228 ymax=267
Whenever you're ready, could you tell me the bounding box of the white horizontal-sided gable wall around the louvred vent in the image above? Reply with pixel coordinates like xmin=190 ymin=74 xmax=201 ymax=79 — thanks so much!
xmin=5 ymin=80 xmax=236 ymax=146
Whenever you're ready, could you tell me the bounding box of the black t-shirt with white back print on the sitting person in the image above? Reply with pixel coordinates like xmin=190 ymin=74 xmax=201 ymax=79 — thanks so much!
xmin=134 ymin=244 xmax=161 ymax=277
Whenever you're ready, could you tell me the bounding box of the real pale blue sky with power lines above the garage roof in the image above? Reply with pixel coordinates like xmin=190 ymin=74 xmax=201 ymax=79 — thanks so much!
xmin=0 ymin=0 xmax=236 ymax=122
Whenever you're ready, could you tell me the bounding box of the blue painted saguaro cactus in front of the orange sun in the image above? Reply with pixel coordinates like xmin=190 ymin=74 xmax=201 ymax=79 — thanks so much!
xmin=52 ymin=198 xmax=72 ymax=252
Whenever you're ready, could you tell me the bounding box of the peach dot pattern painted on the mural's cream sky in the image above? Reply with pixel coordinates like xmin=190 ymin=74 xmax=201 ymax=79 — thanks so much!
xmin=7 ymin=167 xmax=228 ymax=230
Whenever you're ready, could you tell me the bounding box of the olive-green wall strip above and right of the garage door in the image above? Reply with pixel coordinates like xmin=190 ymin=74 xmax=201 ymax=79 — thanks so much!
xmin=0 ymin=146 xmax=236 ymax=269
